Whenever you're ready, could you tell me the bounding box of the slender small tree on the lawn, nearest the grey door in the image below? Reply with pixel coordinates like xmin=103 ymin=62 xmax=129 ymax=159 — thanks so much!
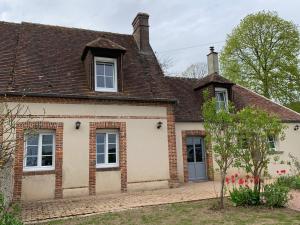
xmin=203 ymin=98 xmax=237 ymax=208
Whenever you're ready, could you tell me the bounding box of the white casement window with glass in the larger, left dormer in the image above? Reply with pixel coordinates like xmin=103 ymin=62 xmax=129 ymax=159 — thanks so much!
xmin=94 ymin=57 xmax=118 ymax=92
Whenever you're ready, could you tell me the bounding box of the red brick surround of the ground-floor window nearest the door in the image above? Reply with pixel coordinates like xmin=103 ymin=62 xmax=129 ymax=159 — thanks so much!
xmin=89 ymin=122 xmax=127 ymax=195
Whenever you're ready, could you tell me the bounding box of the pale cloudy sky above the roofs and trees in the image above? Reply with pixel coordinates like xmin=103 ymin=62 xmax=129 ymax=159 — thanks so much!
xmin=0 ymin=0 xmax=300 ymax=74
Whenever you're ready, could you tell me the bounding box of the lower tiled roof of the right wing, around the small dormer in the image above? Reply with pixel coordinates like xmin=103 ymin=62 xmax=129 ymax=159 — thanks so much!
xmin=166 ymin=75 xmax=300 ymax=122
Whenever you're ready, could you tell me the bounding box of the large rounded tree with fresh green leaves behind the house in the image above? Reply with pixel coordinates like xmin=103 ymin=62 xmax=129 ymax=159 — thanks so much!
xmin=220 ymin=11 xmax=300 ymax=104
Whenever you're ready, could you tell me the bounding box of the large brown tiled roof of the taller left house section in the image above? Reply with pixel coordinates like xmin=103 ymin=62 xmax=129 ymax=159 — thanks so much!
xmin=0 ymin=22 xmax=172 ymax=100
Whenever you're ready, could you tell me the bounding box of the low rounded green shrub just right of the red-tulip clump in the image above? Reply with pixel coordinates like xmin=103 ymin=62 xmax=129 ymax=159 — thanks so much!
xmin=262 ymin=183 xmax=289 ymax=207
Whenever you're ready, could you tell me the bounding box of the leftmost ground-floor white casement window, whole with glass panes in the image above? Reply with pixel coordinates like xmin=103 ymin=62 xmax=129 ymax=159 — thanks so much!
xmin=24 ymin=132 xmax=55 ymax=171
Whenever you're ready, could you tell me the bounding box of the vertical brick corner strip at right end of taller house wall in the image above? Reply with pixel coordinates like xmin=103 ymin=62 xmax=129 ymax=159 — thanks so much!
xmin=167 ymin=105 xmax=178 ymax=188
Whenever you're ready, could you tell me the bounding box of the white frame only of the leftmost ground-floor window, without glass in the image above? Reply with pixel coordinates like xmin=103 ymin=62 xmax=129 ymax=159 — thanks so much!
xmin=23 ymin=132 xmax=56 ymax=172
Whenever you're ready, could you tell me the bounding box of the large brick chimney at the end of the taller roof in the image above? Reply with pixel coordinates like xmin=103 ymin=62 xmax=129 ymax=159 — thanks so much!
xmin=132 ymin=13 xmax=151 ymax=52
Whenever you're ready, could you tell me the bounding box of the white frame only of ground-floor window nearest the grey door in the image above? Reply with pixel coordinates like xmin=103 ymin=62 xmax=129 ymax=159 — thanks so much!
xmin=95 ymin=130 xmax=119 ymax=168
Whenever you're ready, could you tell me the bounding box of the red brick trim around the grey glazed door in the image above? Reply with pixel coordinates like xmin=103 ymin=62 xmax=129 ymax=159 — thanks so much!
xmin=181 ymin=130 xmax=214 ymax=183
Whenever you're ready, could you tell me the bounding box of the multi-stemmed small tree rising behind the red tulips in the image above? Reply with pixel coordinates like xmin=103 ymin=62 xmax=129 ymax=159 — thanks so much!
xmin=235 ymin=107 xmax=284 ymax=193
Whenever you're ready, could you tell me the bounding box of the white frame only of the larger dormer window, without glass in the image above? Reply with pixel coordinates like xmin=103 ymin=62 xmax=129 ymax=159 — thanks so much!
xmin=94 ymin=57 xmax=118 ymax=92
